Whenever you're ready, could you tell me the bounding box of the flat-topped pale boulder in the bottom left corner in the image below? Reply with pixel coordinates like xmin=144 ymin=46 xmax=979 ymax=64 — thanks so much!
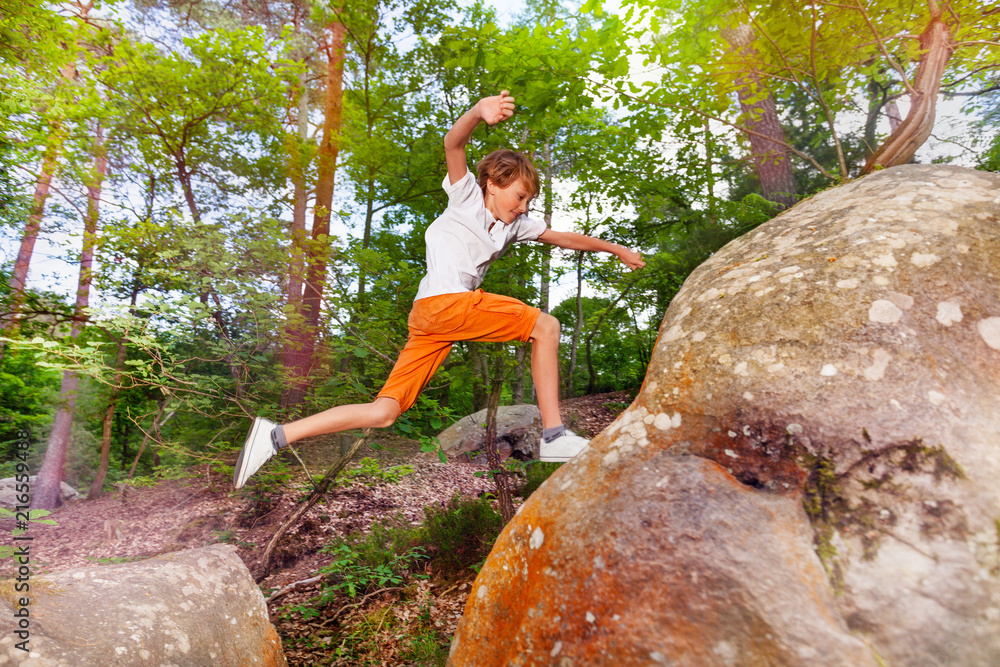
xmin=0 ymin=544 xmax=287 ymax=667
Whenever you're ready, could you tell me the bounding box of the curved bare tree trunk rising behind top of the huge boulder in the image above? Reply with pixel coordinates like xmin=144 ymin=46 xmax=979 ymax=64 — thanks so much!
xmin=861 ymin=13 xmax=955 ymax=174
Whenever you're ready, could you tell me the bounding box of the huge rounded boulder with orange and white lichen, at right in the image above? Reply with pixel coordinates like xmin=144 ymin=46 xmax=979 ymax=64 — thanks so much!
xmin=450 ymin=165 xmax=1000 ymax=666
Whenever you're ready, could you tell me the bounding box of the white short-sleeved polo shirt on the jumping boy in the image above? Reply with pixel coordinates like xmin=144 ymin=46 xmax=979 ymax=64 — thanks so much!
xmin=416 ymin=171 xmax=545 ymax=299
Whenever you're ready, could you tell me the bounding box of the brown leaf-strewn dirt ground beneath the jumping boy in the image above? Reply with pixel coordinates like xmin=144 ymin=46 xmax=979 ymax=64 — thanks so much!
xmin=0 ymin=392 xmax=630 ymax=665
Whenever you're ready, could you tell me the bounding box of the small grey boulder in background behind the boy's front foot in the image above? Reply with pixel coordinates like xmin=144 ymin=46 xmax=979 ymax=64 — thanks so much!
xmin=438 ymin=405 xmax=542 ymax=459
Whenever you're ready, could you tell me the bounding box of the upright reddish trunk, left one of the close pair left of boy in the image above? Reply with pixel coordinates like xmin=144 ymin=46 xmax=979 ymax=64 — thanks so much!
xmin=281 ymin=65 xmax=309 ymax=410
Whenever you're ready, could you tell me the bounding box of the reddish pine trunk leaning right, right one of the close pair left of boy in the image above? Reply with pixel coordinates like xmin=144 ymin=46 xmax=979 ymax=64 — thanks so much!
xmin=296 ymin=18 xmax=346 ymax=400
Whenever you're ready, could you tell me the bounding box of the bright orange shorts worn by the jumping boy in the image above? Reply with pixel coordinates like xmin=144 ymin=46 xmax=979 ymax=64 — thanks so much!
xmin=378 ymin=289 xmax=542 ymax=412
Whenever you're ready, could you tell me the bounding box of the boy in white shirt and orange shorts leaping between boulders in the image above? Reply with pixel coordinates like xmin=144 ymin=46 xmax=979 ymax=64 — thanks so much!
xmin=233 ymin=90 xmax=645 ymax=489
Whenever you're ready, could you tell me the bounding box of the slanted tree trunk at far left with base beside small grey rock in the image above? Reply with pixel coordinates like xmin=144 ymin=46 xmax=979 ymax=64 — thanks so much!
xmin=31 ymin=125 xmax=108 ymax=510
